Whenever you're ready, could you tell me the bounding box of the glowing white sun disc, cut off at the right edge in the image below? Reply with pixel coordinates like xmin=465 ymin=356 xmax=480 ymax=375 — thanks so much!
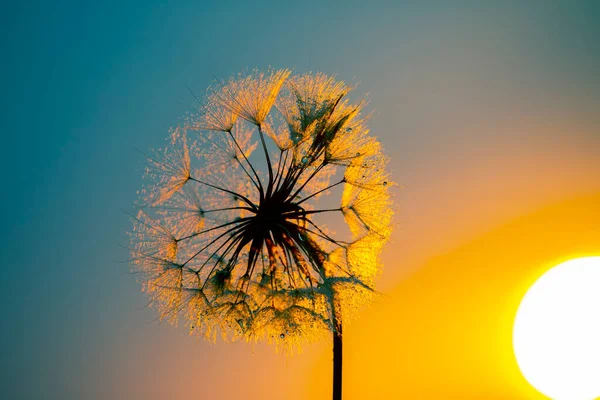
xmin=513 ymin=257 xmax=600 ymax=400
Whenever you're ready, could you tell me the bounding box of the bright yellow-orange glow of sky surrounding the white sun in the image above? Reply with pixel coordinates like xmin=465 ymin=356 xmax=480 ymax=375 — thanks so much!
xmin=311 ymin=192 xmax=600 ymax=400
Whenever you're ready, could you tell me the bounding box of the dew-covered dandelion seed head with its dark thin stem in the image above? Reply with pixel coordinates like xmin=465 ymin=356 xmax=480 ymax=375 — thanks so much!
xmin=131 ymin=70 xmax=392 ymax=399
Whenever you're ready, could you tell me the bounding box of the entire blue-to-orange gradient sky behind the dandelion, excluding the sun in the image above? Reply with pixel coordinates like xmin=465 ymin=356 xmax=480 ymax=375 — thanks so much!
xmin=0 ymin=1 xmax=600 ymax=400
